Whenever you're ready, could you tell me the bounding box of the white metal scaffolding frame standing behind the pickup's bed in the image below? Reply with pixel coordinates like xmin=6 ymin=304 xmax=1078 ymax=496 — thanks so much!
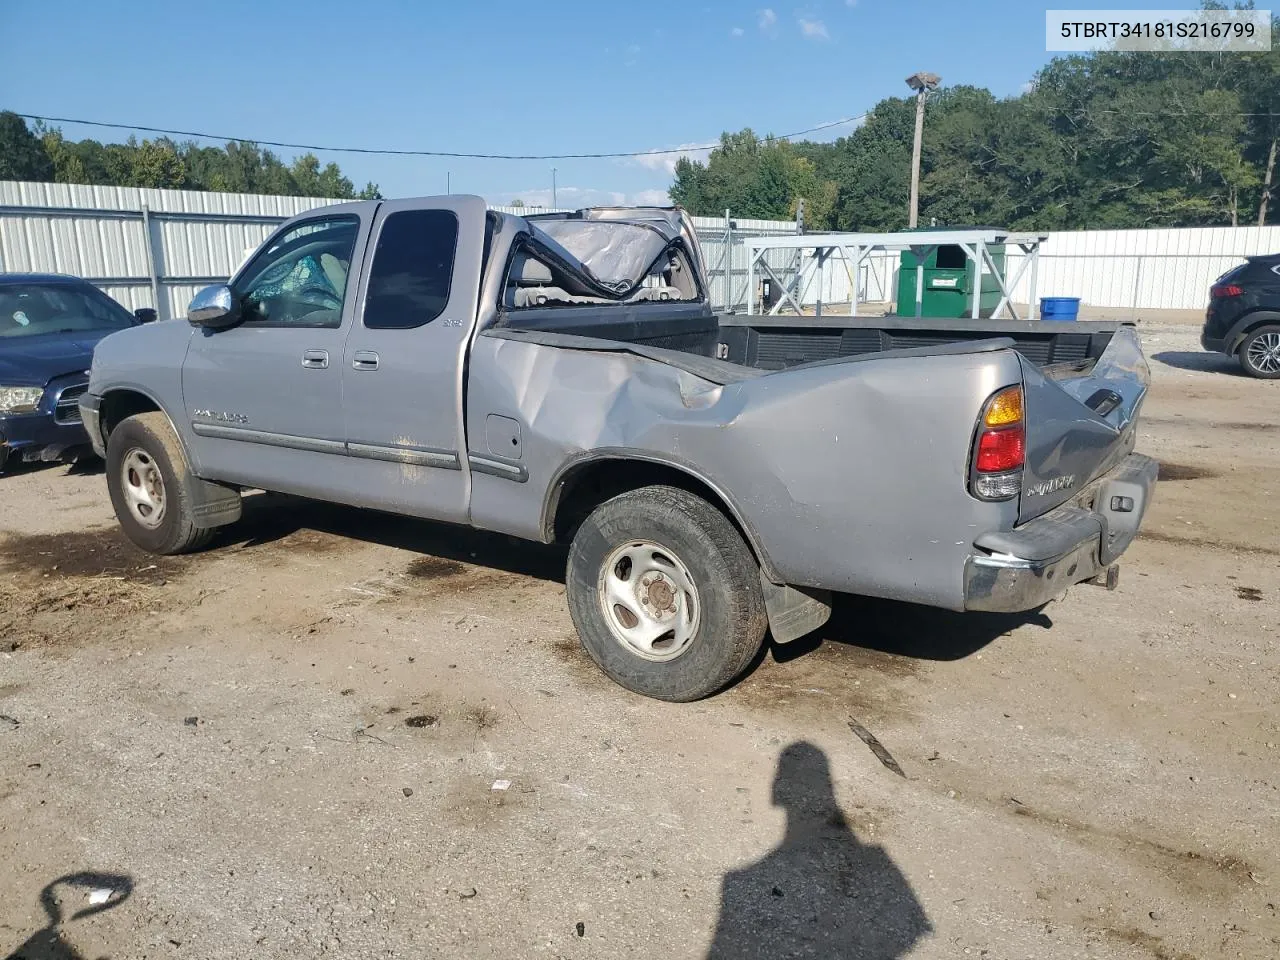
xmin=746 ymin=230 xmax=1048 ymax=320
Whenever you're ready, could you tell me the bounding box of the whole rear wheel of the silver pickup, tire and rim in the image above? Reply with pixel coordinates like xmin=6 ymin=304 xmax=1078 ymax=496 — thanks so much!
xmin=566 ymin=486 xmax=768 ymax=703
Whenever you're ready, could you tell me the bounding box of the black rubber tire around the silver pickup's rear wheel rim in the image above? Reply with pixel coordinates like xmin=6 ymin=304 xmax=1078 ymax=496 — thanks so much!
xmin=566 ymin=486 xmax=768 ymax=703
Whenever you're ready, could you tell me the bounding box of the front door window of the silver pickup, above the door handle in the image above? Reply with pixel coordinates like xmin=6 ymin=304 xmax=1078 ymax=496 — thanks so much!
xmin=236 ymin=216 xmax=360 ymax=326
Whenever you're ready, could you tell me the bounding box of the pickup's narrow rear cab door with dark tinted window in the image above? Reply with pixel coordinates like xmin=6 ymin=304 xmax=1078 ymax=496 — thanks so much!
xmin=342 ymin=196 xmax=488 ymax=522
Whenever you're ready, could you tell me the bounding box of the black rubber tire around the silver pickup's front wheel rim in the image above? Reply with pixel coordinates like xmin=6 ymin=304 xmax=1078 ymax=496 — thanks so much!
xmin=106 ymin=411 xmax=214 ymax=556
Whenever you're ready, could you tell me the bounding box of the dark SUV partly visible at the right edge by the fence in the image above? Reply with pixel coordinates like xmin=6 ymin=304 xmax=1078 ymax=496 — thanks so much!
xmin=1201 ymin=253 xmax=1280 ymax=380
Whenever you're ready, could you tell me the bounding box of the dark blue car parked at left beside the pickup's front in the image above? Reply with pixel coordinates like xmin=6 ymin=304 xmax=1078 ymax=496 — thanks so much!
xmin=0 ymin=274 xmax=156 ymax=471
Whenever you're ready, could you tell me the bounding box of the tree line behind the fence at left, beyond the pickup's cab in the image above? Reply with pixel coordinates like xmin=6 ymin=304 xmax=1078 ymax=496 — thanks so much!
xmin=0 ymin=110 xmax=381 ymax=200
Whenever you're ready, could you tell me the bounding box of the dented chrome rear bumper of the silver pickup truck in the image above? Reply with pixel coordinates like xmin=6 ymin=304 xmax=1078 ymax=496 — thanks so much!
xmin=964 ymin=453 xmax=1158 ymax=613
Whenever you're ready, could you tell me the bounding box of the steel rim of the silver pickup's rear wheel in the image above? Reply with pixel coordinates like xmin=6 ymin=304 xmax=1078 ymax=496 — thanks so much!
xmin=596 ymin=540 xmax=701 ymax=663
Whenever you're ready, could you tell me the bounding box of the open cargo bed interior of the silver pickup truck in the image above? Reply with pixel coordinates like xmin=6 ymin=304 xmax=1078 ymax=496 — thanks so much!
xmin=716 ymin=320 xmax=1132 ymax=370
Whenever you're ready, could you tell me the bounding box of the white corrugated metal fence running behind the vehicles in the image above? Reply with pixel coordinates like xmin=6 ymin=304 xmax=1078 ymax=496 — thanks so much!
xmin=0 ymin=182 xmax=1280 ymax=319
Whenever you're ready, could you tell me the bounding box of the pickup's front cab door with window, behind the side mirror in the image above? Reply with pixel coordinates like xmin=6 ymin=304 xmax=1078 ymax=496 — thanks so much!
xmin=182 ymin=204 xmax=375 ymax=499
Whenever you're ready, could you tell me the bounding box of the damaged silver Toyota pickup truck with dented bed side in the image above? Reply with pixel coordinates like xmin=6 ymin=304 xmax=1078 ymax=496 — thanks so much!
xmin=81 ymin=196 xmax=1156 ymax=700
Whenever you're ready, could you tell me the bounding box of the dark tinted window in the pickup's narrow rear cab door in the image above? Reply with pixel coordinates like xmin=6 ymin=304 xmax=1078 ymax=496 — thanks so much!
xmin=365 ymin=210 xmax=458 ymax=330
